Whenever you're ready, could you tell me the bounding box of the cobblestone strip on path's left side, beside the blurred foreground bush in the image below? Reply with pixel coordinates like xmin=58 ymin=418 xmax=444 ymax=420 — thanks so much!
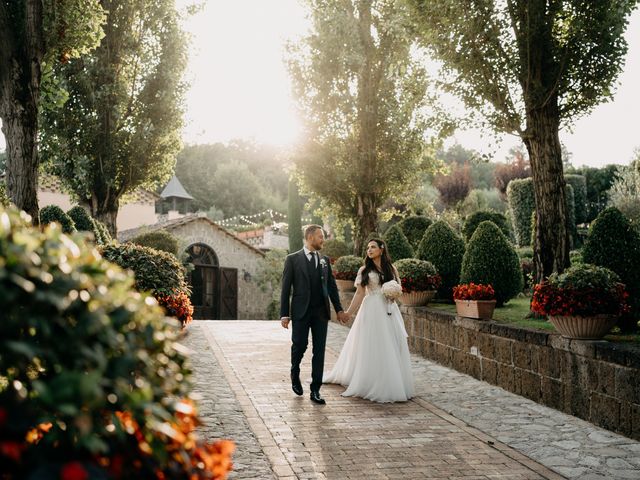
xmin=182 ymin=322 xmax=276 ymax=479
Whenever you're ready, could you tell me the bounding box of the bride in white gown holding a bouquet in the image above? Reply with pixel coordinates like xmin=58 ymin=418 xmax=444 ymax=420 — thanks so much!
xmin=323 ymin=239 xmax=413 ymax=402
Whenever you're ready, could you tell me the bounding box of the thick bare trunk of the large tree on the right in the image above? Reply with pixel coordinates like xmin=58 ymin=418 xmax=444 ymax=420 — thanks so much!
xmin=524 ymin=98 xmax=569 ymax=283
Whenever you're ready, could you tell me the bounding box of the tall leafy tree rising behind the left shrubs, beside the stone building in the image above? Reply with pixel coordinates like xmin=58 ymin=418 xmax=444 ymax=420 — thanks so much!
xmin=42 ymin=0 xmax=187 ymax=234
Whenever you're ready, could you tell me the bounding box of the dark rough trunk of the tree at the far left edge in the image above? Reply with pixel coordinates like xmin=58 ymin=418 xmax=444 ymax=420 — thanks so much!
xmin=0 ymin=0 xmax=44 ymax=224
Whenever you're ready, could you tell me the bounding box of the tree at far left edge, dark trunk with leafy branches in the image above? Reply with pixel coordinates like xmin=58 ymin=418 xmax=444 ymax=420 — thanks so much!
xmin=0 ymin=0 xmax=104 ymax=222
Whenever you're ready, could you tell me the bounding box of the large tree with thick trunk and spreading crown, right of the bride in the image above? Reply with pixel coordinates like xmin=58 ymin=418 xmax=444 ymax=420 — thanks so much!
xmin=408 ymin=0 xmax=637 ymax=280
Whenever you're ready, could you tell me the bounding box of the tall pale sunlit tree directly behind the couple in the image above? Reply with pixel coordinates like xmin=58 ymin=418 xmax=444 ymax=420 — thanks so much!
xmin=289 ymin=0 xmax=438 ymax=253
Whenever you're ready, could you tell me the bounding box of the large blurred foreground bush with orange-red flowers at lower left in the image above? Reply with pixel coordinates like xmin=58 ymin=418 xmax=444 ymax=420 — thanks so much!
xmin=0 ymin=208 xmax=232 ymax=480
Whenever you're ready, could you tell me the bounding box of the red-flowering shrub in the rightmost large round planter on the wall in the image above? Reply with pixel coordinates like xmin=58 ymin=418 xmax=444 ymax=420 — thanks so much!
xmin=531 ymin=264 xmax=629 ymax=316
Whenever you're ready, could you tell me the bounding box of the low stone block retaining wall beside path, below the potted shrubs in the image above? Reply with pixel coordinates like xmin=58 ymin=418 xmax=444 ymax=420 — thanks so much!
xmin=342 ymin=294 xmax=640 ymax=440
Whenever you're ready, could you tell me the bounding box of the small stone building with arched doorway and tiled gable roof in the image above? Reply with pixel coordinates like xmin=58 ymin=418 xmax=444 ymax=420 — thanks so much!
xmin=118 ymin=215 xmax=271 ymax=320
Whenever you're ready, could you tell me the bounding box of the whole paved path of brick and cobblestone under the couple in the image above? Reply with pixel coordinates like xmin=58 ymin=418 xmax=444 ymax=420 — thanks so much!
xmin=184 ymin=321 xmax=640 ymax=480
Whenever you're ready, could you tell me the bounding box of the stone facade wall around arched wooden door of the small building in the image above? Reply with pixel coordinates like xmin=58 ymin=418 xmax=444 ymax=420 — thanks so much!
xmin=170 ymin=219 xmax=271 ymax=320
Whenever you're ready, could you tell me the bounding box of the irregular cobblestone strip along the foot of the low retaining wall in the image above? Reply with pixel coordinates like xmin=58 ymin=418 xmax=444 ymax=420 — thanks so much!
xmin=327 ymin=324 xmax=640 ymax=480
